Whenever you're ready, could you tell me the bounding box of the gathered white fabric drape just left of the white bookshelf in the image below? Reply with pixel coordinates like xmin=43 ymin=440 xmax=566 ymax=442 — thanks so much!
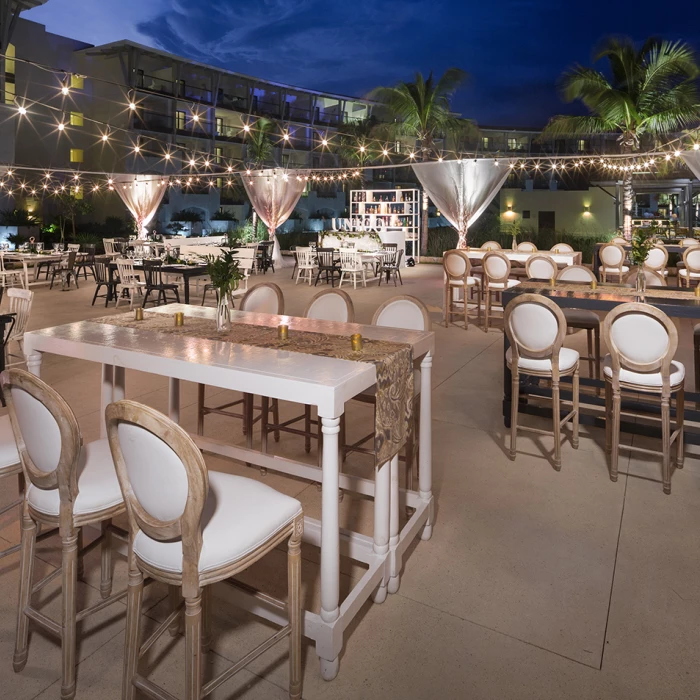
xmin=243 ymin=168 xmax=306 ymax=267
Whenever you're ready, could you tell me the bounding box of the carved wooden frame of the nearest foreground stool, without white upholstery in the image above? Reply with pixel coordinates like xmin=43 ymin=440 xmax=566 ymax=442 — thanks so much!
xmin=105 ymin=400 xmax=304 ymax=700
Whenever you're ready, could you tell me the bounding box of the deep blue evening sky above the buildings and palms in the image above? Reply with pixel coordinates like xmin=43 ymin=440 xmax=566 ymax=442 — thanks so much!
xmin=23 ymin=0 xmax=700 ymax=127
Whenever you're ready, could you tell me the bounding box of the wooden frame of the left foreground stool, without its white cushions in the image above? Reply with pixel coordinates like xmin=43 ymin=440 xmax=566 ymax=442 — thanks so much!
xmin=0 ymin=369 xmax=126 ymax=700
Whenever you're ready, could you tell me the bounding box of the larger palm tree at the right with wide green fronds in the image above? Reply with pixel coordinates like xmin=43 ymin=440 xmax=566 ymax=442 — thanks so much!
xmin=542 ymin=37 xmax=700 ymax=239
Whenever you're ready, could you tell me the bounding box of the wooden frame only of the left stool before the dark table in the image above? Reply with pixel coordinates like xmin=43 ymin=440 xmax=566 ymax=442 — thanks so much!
xmin=504 ymin=294 xmax=579 ymax=471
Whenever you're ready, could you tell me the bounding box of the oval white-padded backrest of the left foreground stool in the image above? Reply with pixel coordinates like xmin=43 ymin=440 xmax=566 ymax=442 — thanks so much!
xmin=0 ymin=369 xmax=81 ymax=506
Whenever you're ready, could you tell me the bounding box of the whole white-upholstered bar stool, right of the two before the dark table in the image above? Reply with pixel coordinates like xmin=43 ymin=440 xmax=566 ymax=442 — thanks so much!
xmin=603 ymin=302 xmax=685 ymax=494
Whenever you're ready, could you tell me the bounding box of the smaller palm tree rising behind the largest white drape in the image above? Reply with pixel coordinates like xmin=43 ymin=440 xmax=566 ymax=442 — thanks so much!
xmin=369 ymin=68 xmax=473 ymax=255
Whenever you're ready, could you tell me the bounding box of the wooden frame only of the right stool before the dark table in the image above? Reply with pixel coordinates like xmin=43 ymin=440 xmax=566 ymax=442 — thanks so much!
xmin=603 ymin=302 xmax=685 ymax=494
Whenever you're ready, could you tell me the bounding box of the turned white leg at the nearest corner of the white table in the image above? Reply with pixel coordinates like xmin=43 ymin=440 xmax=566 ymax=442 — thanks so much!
xmin=317 ymin=418 xmax=340 ymax=681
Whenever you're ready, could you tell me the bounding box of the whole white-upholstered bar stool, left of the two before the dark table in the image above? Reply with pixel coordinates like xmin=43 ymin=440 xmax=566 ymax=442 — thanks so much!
xmin=504 ymin=294 xmax=579 ymax=471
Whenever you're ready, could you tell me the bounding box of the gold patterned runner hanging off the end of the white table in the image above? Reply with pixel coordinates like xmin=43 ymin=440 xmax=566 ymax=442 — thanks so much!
xmin=91 ymin=312 xmax=413 ymax=464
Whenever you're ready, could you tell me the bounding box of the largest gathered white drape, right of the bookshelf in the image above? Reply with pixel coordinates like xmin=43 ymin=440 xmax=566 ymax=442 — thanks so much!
xmin=412 ymin=158 xmax=510 ymax=248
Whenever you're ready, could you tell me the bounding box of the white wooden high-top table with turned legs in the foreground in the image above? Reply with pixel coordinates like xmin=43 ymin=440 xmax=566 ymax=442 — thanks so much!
xmin=24 ymin=304 xmax=435 ymax=680
